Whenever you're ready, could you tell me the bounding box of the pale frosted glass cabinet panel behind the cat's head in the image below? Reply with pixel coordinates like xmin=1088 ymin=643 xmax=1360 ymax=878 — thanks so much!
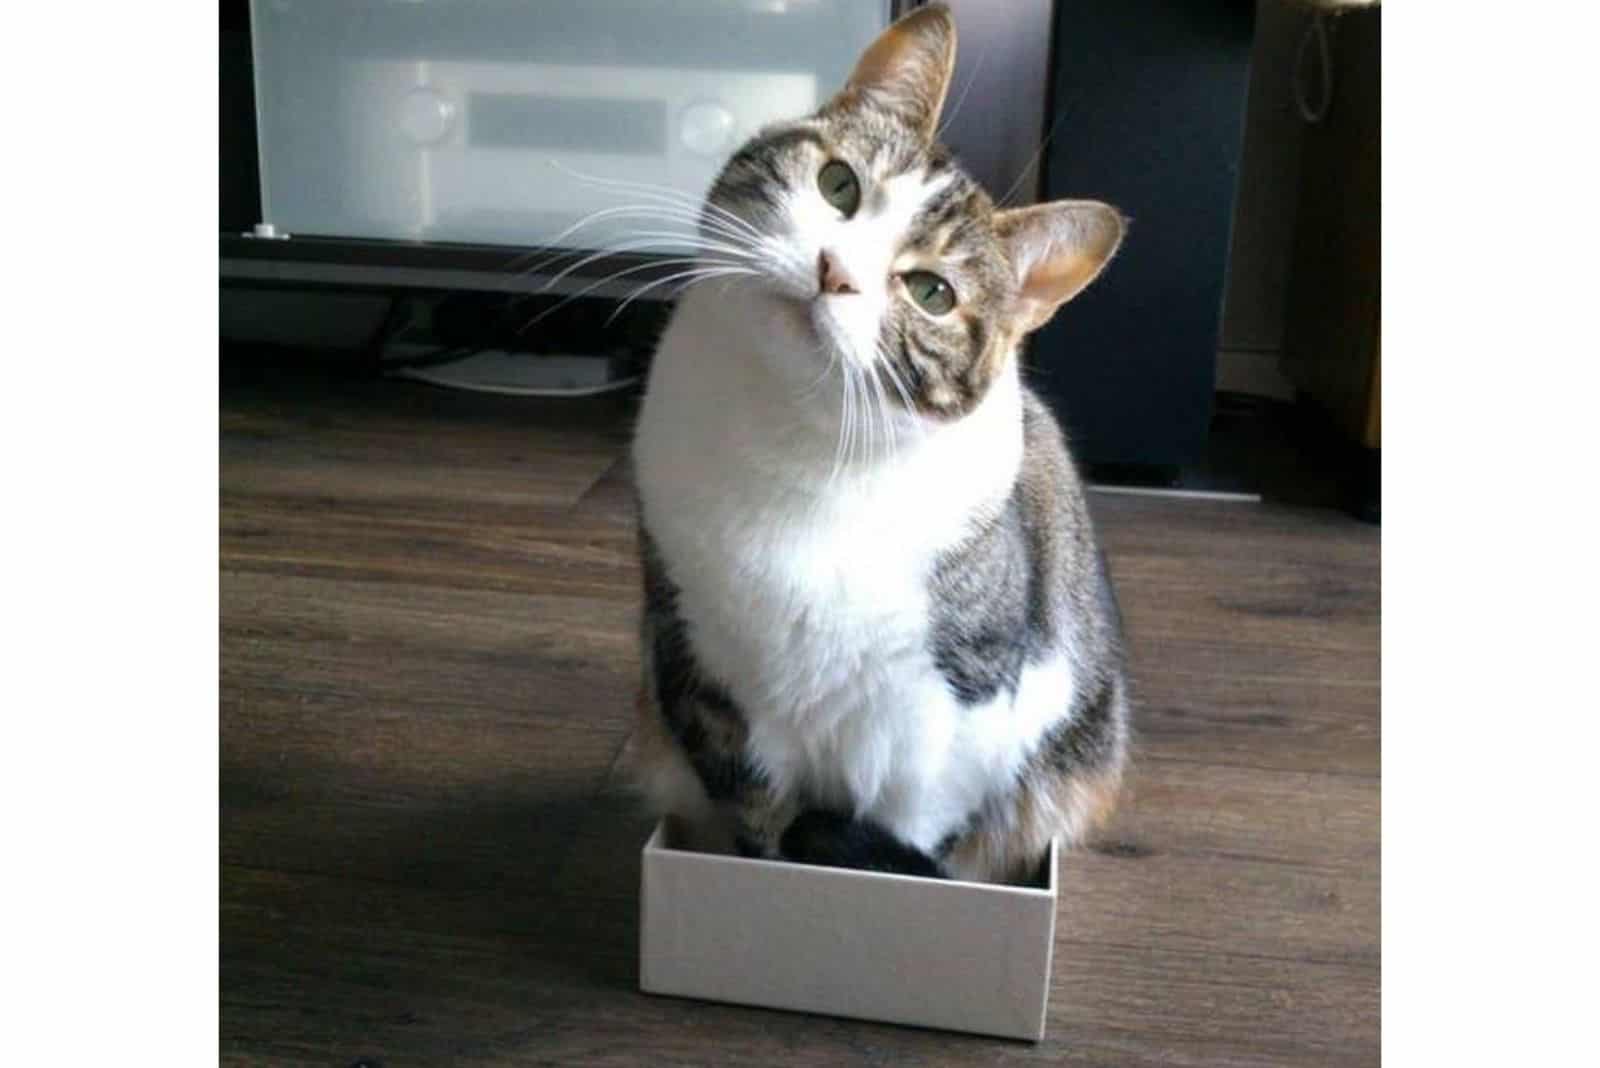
xmin=251 ymin=0 xmax=890 ymax=251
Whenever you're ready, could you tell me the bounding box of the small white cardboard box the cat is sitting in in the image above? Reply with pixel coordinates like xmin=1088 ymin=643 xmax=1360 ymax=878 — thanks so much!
xmin=638 ymin=822 xmax=1058 ymax=1041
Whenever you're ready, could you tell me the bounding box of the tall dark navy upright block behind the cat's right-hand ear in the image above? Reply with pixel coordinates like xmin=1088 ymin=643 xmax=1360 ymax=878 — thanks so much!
xmin=1029 ymin=0 xmax=1254 ymax=468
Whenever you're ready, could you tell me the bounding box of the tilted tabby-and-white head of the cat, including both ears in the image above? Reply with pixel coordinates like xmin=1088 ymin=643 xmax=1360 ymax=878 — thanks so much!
xmin=702 ymin=5 xmax=1123 ymax=419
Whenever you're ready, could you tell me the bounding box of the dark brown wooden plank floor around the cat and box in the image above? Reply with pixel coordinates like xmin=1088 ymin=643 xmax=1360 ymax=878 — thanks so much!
xmin=221 ymin=362 xmax=1379 ymax=1068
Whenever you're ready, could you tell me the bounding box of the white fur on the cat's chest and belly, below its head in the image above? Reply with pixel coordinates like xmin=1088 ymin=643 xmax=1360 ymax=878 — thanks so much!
xmin=635 ymin=293 xmax=1070 ymax=849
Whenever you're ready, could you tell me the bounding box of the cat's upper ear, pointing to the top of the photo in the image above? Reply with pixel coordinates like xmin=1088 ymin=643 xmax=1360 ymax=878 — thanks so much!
xmin=824 ymin=3 xmax=955 ymax=142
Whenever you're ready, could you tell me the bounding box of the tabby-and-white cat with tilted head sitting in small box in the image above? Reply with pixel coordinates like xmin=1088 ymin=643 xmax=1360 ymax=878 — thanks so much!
xmin=632 ymin=5 xmax=1130 ymax=881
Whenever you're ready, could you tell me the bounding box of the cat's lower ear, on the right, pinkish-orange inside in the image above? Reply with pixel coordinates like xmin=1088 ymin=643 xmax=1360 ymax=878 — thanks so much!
xmin=995 ymin=200 xmax=1123 ymax=333
